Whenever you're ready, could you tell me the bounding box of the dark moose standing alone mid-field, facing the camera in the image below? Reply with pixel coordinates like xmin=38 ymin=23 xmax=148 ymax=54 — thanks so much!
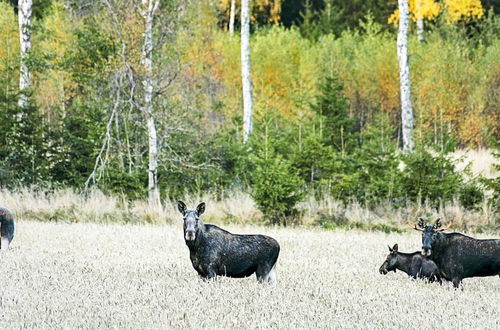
xmin=177 ymin=201 xmax=280 ymax=283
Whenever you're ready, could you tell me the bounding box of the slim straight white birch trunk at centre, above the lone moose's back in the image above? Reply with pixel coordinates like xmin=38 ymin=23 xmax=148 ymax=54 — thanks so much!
xmin=241 ymin=0 xmax=252 ymax=142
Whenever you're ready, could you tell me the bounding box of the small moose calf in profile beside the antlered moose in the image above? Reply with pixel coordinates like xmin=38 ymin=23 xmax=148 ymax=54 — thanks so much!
xmin=379 ymin=244 xmax=441 ymax=283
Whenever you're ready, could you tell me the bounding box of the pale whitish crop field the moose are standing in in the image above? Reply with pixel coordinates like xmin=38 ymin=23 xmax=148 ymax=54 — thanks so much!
xmin=0 ymin=219 xmax=500 ymax=329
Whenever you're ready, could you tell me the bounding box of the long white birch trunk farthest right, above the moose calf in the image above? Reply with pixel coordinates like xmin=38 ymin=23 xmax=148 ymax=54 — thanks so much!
xmin=397 ymin=0 xmax=413 ymax=153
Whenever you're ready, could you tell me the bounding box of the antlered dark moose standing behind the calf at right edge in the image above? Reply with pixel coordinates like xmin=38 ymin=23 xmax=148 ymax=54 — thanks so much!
xmin=414 ymin=218 xmax=500 ymax=288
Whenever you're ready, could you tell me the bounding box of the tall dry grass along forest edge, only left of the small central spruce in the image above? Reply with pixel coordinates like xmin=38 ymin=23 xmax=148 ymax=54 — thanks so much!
xmin=0 ymin=188 xmax=262 ymax=224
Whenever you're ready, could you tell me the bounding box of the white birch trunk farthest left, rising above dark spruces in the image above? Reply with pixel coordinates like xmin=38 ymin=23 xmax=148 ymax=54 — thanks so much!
xmin=18 ymin=0 xmax=32 ymax=108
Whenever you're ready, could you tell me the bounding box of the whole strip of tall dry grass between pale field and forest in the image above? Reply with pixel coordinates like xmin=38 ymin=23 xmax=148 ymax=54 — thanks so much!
xmin=0 ymin=188 xmax=500 ymax=231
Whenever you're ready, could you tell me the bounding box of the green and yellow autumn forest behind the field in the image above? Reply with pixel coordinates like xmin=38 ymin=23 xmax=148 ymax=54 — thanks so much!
xmin=0 ymin=0 xmax=500 ymax=230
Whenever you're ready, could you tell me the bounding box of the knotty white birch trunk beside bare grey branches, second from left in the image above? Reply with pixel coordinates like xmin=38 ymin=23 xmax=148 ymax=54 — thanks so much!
xmin=141 ymin=0 xmax=160 ymax=206
